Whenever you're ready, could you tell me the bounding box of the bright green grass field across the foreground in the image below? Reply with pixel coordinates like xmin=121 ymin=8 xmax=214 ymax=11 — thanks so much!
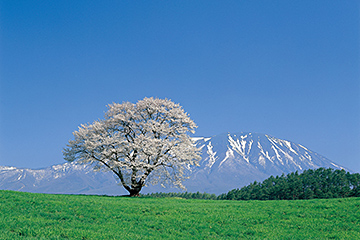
xmin=0 ymin=191 xmax=360 ymax=239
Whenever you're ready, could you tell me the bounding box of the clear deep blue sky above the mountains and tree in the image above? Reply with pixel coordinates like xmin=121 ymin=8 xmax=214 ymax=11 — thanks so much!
xmin=0 ymin=0 xmax=360 ymax=172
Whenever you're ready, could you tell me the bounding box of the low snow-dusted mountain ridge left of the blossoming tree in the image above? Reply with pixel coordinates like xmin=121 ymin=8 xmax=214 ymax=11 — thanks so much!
xmin=0 ymin=163 xmax=125 ymax=195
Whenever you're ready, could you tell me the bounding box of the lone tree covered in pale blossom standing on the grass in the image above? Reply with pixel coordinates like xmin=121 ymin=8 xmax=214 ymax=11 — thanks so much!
xmin=63 ymin=98 xmax=200 ymax=196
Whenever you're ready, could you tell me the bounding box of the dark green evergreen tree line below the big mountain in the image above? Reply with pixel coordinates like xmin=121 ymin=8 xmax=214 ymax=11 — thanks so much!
xmin=218 ymin=168 xmax=360 ymax=200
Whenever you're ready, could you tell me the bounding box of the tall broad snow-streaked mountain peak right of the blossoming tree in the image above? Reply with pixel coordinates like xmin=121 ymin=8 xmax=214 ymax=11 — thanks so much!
xmin=185 ymin=133 xmax=348 ymax=194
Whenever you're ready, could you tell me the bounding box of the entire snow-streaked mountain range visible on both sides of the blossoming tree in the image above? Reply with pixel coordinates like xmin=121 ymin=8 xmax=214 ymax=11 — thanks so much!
xmin=0 ymin=133 xmax=348 ymax=195
